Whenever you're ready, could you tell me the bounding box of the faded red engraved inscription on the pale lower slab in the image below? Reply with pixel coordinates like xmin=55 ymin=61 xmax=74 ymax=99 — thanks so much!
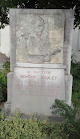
xmin=15 ymin=70 xmax=62 ymax=97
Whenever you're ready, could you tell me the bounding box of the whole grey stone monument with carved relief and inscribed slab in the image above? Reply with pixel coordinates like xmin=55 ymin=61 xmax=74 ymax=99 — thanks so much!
xmin=1 ymin=9 xmax=73 ymax=121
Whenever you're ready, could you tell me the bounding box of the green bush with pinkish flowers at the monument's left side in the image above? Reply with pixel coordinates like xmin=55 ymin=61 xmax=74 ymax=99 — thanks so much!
xmin=0 ymin=59 xmax=10 ymax=102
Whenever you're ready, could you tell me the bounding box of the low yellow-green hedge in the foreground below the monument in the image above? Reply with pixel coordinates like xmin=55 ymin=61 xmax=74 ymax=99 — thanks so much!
xmin=0 ymin=109 xmax=67 ymax=139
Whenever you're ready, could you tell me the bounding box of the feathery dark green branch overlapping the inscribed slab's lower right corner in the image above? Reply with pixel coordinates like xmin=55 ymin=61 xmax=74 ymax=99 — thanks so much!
xmin=50 ymin=99 xmax=77 ymax=123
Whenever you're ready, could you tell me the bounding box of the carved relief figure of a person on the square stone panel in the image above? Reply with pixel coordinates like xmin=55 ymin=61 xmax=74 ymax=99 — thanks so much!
xmin=15 ymin=15 xmax=61 ymax=63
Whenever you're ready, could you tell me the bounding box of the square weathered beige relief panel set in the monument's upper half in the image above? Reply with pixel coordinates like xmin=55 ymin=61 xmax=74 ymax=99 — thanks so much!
xmin=16 ymin=13 xmax=65 ymax=63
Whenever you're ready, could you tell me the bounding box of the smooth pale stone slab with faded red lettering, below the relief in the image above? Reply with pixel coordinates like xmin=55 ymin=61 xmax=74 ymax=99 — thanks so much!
xmin=11 ymin=67 xmax=65 ymax=116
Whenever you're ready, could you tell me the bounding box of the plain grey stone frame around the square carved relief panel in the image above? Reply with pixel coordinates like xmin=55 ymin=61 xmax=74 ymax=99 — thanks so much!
xmin=10 ymin=9 xmax=74 ymax=74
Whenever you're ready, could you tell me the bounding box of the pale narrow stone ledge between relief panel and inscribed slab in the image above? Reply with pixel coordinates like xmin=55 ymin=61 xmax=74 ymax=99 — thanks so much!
xmin=14 ymin=63 xmax=66 ymax=69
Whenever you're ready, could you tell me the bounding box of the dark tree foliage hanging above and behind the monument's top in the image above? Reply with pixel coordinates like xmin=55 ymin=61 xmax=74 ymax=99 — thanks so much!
xmin=0 ymin=0 xmax=80 ymax=29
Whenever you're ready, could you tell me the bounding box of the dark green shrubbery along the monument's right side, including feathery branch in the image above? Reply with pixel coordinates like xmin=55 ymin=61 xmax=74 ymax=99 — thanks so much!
xmin=51 ymin=54 xmax=80 ymax=139
